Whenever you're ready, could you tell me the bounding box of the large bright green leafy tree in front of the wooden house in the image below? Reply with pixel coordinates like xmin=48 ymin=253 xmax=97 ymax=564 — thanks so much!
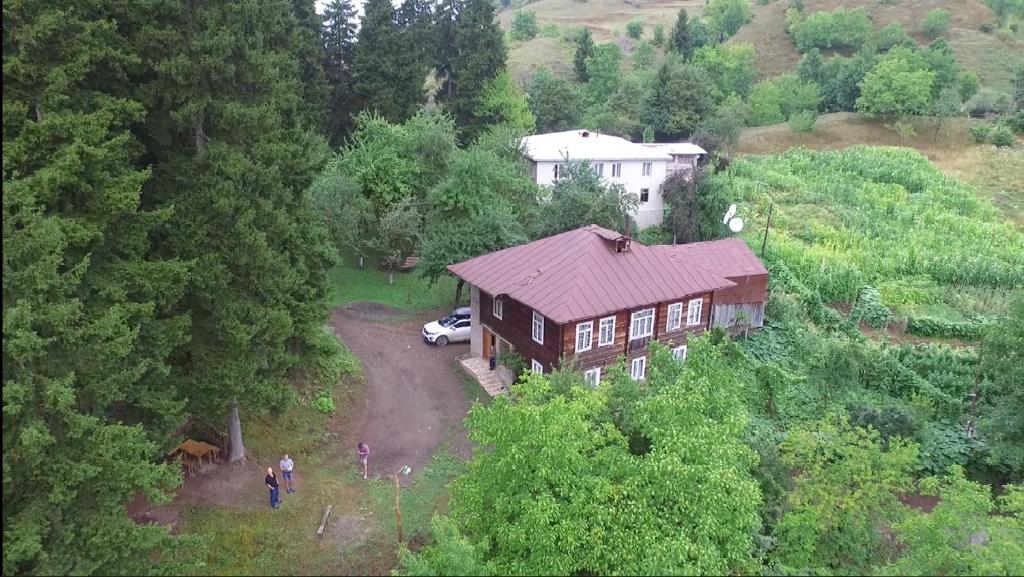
xmin=403 ymin=339 xmax=760 ymax=574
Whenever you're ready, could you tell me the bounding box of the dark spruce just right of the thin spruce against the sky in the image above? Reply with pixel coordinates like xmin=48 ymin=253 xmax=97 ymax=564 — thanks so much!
xmin=352 ymin=0 xmax=426 ymax=122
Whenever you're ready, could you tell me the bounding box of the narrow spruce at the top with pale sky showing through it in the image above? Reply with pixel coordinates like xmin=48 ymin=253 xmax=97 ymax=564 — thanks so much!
xmin=321 ymin=0 xmax=357 ymax=147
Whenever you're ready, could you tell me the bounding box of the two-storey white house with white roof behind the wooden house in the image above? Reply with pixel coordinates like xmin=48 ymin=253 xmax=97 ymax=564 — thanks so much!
xmin=522 ymin=130 xmax=707 ymax=229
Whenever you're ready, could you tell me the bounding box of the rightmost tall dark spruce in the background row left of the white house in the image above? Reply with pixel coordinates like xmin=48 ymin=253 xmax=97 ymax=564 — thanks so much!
xmin=449 ymin=0 xmax=507 ymax=141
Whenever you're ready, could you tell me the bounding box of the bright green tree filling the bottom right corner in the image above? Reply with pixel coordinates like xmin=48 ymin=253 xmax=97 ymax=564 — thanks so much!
xmin=880 ymin=465 xmax=1024 ymax=575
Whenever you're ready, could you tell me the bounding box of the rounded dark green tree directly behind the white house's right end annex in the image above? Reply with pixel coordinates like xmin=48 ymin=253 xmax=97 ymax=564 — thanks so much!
xmin=643 ymin=57 xmax=715 ymax=141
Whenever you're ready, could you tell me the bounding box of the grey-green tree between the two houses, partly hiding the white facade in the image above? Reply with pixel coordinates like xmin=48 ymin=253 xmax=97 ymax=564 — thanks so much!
xmin=534 ymin=160 xmax=640 ymax=237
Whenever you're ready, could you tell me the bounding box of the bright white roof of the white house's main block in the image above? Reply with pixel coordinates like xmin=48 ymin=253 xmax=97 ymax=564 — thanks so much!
xmin=522 ymin=130 xmax=672 ymax=162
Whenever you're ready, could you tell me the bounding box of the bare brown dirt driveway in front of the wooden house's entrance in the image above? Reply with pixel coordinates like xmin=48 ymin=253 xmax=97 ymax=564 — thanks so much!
xmin=331 ymin=302 xmax=470 ymax=476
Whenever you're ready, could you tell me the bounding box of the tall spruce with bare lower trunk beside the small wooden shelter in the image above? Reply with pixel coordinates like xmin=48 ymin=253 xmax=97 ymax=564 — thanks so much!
xmin=141 ymin=0 xmax=333 ymax=460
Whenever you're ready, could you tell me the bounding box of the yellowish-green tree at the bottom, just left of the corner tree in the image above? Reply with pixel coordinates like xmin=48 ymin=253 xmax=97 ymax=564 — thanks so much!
xmin=772 ymin=416 xmax=918 ymax=575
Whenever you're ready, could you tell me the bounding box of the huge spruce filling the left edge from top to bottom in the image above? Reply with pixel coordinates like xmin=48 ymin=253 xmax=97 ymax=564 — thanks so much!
xmin=3 ymin=0 xmax=200 ymax=575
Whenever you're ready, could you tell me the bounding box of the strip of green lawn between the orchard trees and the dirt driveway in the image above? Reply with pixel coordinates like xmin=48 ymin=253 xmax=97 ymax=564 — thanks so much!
xmin=331 ymin=257 xmax=458 ymax=311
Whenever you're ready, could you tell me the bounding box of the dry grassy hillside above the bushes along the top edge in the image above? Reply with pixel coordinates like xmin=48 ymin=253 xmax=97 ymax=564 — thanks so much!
xmin=498 ymin=0 xmax=1024 ymax=91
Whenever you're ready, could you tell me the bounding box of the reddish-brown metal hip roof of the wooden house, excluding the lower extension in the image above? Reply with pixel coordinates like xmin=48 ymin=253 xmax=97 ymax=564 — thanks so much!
xmin=447 ymin=224 xmax=735 ymax=324
